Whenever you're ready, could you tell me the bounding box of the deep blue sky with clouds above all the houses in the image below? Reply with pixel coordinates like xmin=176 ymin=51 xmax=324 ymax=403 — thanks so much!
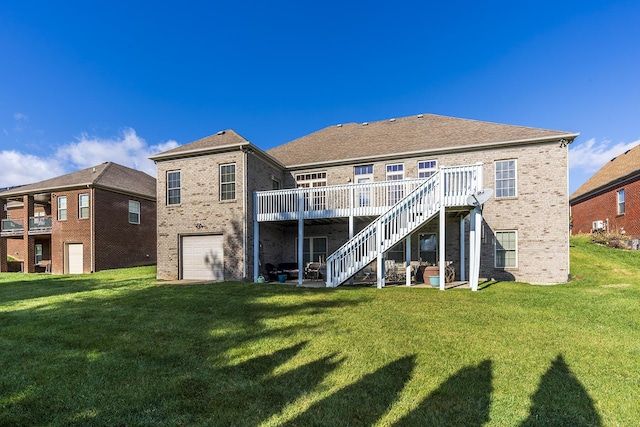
xmin=0 ymin=0 xmax=640 ymax=192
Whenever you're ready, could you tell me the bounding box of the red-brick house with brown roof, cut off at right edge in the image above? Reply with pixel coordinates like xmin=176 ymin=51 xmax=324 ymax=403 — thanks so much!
xmin=569 ymin=145 xmax=640 ymax=238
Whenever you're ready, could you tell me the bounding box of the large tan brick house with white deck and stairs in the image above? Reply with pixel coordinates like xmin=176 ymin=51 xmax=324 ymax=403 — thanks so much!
xmin=152 ymin=114 xmax=577 ymax=288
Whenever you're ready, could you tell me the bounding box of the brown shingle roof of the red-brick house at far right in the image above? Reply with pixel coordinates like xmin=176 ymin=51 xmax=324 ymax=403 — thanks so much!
xmin=569 ymin=140 xmax=640 ymax=201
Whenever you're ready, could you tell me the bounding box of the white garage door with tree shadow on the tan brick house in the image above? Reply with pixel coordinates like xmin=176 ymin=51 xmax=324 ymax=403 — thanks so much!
xmin=181 ymin=235 xmax=224 ymax=280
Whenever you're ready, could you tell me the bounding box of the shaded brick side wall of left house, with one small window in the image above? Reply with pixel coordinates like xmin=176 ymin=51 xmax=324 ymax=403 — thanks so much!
xmin=93 ymin=188 xmax=156 ymax=271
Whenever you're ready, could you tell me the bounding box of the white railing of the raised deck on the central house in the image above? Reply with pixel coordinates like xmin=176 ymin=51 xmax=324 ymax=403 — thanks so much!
xmin=254 ymin=163 xmax=482 ymax=222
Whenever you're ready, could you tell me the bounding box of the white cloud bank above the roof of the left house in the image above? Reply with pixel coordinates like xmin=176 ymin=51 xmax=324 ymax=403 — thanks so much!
xmin=0 ymin=128 xmax=179 ymax=187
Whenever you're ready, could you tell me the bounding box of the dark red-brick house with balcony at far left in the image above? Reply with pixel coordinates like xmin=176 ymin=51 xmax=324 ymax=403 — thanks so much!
xmin=0 ymin=162 xmax=156 ymax=274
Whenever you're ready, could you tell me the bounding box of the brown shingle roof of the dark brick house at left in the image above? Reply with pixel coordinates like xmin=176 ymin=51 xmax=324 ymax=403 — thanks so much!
xmin=0 ymin=162 xmax=156 ymax=199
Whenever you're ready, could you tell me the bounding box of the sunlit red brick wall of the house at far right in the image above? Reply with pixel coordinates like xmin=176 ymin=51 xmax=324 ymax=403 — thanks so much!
xmin=571 ymin=176 xmax=640 ymax=237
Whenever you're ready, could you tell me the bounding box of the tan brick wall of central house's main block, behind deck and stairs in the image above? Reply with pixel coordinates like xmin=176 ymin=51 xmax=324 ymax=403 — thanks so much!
xmin=272 ymin=142 xmax=569 ymax=283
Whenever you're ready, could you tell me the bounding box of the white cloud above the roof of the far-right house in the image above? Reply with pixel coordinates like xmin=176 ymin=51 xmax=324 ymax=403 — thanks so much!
xmin=569 ymin=138 xmax=640 ymax=173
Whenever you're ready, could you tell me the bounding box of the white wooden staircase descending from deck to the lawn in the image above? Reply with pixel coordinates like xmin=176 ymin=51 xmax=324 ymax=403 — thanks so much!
xmin=327 ymin=164 xmax=482 ymax=287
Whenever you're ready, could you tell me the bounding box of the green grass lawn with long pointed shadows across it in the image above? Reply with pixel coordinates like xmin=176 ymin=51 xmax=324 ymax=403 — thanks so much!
xmin=0 ymin=239 xmax=640 ymax=426
